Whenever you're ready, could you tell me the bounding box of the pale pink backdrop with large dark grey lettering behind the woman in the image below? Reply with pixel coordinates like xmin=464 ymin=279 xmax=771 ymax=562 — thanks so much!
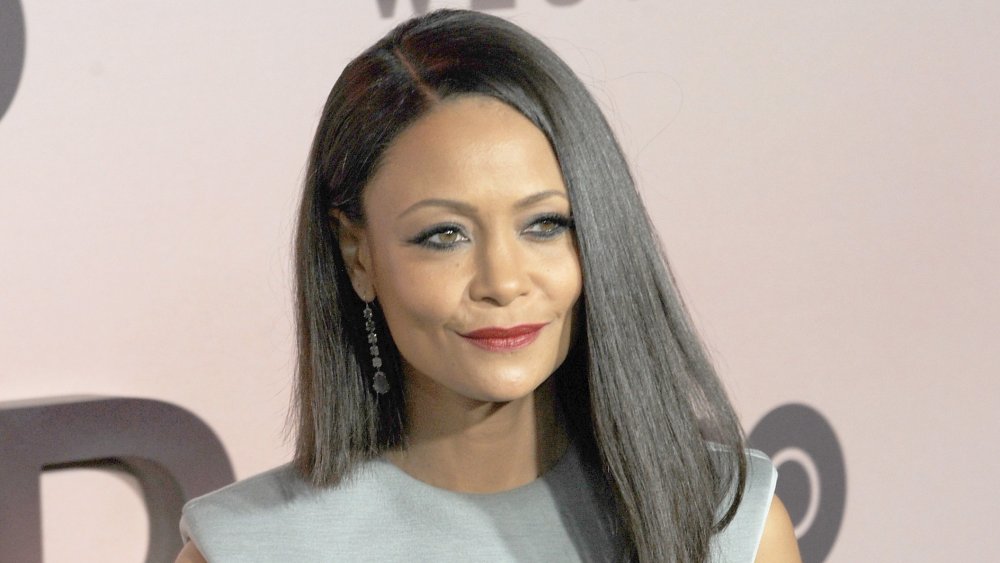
xmin=0 ymin=0 xmax=1000 ymax=563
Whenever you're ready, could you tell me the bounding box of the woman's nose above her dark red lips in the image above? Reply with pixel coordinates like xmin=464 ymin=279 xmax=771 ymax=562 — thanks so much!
xmin=469 ymin=231 xmax=531 ymax=307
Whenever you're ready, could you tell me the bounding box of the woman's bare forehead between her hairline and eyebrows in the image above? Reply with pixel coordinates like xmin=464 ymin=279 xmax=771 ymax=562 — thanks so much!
xmin=364 ymin=96 xmax=566 ymax=216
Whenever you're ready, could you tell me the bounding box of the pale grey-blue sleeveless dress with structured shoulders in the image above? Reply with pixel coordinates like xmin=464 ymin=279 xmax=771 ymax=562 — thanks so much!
xmin=180 ymin=447 xmax=776 ymax=563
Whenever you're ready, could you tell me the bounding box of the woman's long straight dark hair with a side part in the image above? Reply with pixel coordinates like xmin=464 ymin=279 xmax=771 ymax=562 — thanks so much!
xmin=295 ymin=10 xmax=747 ymax=563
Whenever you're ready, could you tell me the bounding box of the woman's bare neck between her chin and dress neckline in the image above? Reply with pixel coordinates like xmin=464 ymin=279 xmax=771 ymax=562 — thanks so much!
xmin=386 ymin=378 xmax=569 ymax=493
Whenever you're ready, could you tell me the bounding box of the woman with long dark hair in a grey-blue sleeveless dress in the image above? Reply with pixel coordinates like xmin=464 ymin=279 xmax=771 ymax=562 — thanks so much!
xmin=179 ymin=11 xmax=799 ymax=562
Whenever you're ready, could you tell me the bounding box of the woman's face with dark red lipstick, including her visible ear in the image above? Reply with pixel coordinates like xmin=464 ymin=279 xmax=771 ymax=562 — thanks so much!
xmin=342 ymin=96 xmax=582 ymax=402
